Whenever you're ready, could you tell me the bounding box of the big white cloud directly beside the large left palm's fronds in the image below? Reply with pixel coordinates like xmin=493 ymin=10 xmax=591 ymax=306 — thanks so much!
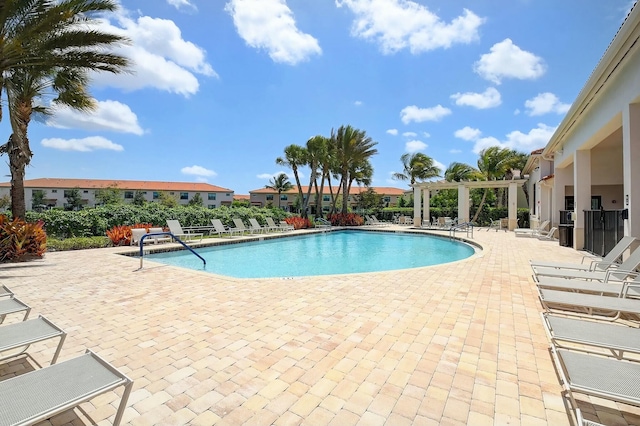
xmin=92 ymin=10 xmax=217 ymax=96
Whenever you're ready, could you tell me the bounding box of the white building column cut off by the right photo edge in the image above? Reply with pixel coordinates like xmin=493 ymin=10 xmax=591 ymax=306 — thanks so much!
xmin=622 ymin=104 xmax=640 ymax=238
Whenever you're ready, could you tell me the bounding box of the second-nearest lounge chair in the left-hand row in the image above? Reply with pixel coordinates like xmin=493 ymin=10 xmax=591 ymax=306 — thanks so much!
xmin=0 ymin=315 xmax=67 ymax=364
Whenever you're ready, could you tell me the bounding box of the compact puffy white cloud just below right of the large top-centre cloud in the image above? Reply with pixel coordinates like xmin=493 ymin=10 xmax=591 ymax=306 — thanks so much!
xmin=473 ymin=38 xmax=546 ymax=84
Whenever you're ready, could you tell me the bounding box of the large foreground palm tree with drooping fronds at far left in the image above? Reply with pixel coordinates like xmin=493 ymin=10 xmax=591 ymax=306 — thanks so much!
xmin=0 ymin=0 xmax=128 ymax=218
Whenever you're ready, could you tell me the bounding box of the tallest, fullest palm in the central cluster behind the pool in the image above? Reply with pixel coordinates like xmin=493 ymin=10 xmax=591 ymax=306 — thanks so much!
xmin=331 ymin=126 xmax=378 ymax=214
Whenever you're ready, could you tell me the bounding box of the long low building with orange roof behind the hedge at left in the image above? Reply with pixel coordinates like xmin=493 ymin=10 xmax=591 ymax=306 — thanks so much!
xmin=0 ymin=178 xmax=233 ymax=210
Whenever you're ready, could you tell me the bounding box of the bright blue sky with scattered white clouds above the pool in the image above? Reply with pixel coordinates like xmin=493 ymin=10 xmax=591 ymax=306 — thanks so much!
xmin=0 ymin=0 xmax=633 ymax=194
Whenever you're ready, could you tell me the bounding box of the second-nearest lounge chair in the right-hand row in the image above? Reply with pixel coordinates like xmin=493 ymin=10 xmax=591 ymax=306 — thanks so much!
xmin=541 ymin=313 xmax=640 ymax=359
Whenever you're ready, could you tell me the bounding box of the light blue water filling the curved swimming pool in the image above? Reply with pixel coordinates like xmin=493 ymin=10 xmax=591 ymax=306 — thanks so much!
xmin=145 ymin=231 xmax=474 ymax=278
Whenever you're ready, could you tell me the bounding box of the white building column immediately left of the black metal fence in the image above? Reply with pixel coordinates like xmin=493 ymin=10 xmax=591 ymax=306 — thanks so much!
xmin=573 ymin=149 xmax=591 ymax=250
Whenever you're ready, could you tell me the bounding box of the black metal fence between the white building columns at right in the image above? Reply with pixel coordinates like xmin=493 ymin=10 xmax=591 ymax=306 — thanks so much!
xmin=584 ymin=210 xmax=624 ymax=256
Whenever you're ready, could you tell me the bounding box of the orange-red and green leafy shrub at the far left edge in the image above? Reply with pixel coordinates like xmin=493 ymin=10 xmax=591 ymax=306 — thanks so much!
xmin=0 ymin=215 xmax=47 ymax=262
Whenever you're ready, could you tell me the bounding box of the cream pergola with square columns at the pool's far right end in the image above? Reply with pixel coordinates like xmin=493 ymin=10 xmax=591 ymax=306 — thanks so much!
xmin=412 ymin=179 xmax=527 ymax=231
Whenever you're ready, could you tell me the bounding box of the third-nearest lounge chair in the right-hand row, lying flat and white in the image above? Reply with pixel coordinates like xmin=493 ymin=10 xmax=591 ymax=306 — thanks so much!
xmin=538 ymin=288 xmax=640 ymax=321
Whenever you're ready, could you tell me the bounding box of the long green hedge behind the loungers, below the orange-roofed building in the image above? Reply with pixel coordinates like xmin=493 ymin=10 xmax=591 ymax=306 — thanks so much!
xmin=26 ymin=203 xmax=290 ymax=238
